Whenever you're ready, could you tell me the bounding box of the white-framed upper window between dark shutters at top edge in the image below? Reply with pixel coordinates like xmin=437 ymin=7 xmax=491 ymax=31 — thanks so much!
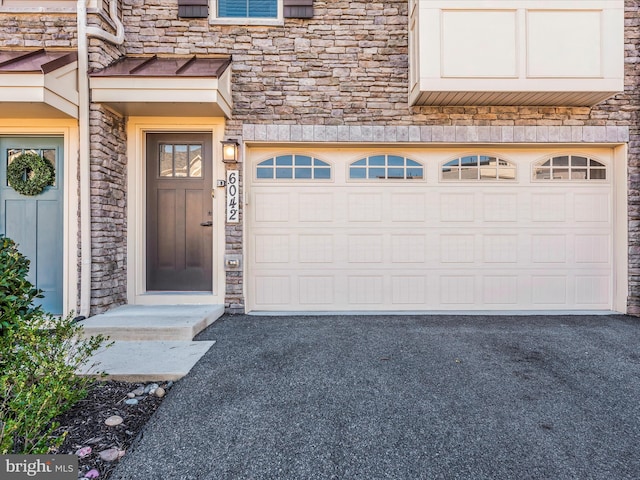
xmin=211 ymin=0 xmax=283 ymax=25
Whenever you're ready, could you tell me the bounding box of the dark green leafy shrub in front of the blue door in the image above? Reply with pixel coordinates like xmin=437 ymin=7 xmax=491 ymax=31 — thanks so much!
xmin=0 ymin=235 xmax=42 ymax=334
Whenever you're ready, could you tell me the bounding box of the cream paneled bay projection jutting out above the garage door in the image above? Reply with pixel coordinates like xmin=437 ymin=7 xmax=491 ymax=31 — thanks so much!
xmin=409 ymin=0 xmax=624 ymax=106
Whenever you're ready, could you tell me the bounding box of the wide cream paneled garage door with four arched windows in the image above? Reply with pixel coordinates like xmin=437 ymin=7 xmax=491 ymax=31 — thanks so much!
xmin=245 ymin=148 xmax=614 ymax=312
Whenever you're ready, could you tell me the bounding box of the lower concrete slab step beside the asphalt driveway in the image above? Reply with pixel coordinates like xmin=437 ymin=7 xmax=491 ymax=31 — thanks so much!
xmin=78 ymin=341 xmax=216 ymax=382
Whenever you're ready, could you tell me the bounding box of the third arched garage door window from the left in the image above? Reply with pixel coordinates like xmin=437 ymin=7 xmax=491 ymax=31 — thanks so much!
xmin=442 ymin=155 xmax=516 ymax=180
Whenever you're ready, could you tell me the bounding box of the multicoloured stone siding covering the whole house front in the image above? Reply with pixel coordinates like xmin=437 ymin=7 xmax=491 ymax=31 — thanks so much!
xmin=0 ymin=0 xmax=640 ymax=314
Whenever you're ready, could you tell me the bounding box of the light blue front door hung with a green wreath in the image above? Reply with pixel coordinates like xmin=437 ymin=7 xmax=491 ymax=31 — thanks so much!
xmin=0 ymin=137 xmax=64 ymax=314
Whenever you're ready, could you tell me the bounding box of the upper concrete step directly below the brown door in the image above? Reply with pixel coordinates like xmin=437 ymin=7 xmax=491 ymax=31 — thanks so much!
xmin=81 ymin=305 xmax=224 ymax=341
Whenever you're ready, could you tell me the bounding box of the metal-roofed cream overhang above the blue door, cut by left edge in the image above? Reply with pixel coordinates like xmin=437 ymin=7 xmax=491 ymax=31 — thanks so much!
xmin=0 ymin=49 xmax=78 ymax=118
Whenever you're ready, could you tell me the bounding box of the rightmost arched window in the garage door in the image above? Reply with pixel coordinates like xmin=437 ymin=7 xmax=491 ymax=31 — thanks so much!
xmin=533 ymin=155 xmax=607 ymax=180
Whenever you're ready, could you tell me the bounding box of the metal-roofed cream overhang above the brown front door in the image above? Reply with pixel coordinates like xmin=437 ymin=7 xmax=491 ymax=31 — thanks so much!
xmin=90 ymin=56 xmax=232 ymax=118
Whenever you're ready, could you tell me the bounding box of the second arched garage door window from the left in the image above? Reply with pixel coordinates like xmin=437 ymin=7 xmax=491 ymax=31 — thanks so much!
xmin=349 ymin=155 xmax=424 ymax=180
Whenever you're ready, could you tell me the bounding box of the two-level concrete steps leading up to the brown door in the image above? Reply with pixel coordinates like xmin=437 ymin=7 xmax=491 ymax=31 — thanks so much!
xmin=80 ymin=305 xmax=224 ymax=382
